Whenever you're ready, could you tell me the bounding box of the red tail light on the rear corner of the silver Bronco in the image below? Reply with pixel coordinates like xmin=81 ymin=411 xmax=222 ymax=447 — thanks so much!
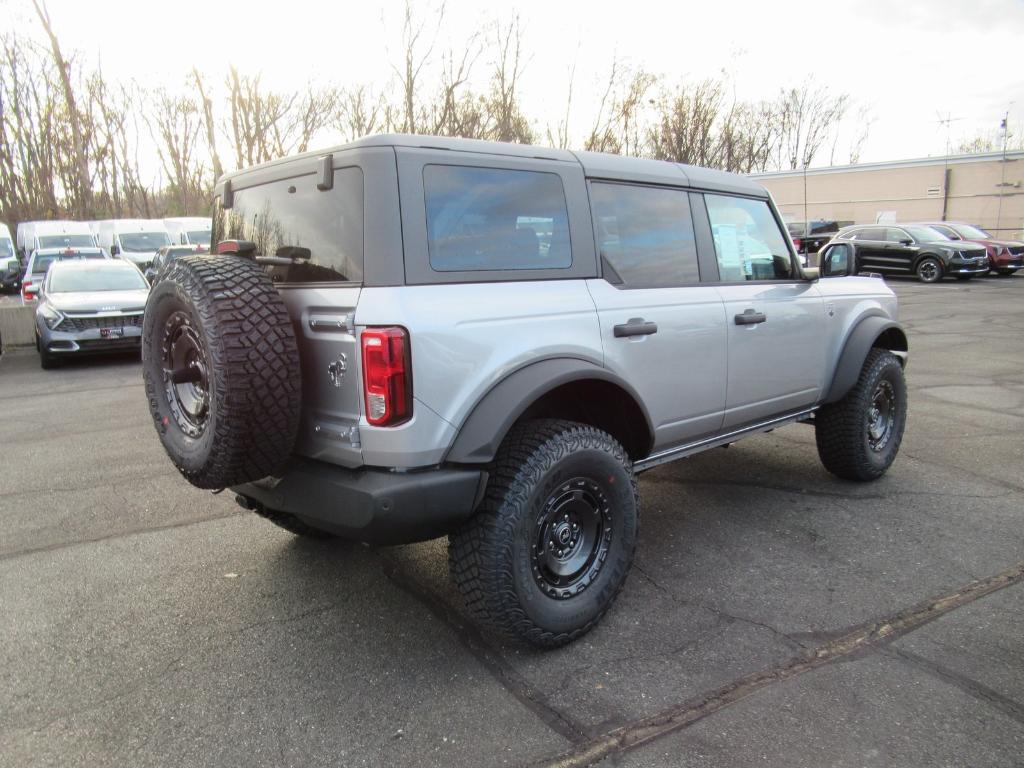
xmin=361 ymin=327 xmax=413 ymax=427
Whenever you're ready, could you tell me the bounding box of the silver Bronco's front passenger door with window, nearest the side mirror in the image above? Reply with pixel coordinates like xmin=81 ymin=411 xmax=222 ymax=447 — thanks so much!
xmin=700 ymin=193 xmax=825 ymax=429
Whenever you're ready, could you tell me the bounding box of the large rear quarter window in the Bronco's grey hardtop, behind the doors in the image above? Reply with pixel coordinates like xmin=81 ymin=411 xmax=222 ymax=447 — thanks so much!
xmin=423 ymin=165 xmax=572 ymax=272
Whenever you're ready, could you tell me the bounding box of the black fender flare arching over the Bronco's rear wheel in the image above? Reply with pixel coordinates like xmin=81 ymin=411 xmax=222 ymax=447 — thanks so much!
xmin=444 ymin=357 xmax=654 ymax=464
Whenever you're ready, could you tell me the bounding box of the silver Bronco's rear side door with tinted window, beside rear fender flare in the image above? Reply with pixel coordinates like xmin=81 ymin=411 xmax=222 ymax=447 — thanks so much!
xmin=588 ymin=180 xmax=726 ymax=450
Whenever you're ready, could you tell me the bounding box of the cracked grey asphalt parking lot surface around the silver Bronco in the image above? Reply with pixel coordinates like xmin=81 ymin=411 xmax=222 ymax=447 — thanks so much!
xmin=0 ymin=276 xmax=1024 ymax=768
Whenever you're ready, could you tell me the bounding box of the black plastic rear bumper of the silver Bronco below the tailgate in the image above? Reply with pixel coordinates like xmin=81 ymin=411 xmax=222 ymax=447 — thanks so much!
xmin=231 ymin=457 xmax=487 ymax=544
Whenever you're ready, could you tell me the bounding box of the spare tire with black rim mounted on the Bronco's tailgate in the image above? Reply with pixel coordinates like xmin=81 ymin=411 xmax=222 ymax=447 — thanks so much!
xmin=142 ymin=256 xmax=302 ymax=488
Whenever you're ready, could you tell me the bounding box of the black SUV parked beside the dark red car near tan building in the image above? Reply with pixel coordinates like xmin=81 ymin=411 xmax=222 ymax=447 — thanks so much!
xmin=831 ymin=224 xmax=988 ymax=283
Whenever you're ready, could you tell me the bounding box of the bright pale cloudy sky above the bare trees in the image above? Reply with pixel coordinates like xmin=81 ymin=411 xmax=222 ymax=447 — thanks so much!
xmin=8 ymin=0 xmax=1024 ymax=165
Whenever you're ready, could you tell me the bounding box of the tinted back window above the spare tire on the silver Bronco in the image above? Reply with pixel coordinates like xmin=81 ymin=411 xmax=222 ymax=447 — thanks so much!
xmin=212 ymin=167 xmax=362 ymax=283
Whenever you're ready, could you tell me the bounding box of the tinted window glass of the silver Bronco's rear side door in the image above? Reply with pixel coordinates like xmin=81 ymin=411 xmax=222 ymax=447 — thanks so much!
xmin=591 ymin=182 xmax=700 ymax=288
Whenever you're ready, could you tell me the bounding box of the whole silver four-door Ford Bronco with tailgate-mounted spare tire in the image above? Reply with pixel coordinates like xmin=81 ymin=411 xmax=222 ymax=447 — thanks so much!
xmin=143 ymin=136 xmax=907 ymax=647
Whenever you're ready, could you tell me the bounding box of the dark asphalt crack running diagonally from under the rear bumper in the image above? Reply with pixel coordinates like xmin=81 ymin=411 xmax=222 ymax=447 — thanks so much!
xmin=380 ymin=553 xmax=587 ymax=744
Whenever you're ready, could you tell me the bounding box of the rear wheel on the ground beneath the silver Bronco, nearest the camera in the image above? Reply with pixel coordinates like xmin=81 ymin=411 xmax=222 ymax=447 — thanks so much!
xmin=449 ymin=419 xmax=640 ymax=648
